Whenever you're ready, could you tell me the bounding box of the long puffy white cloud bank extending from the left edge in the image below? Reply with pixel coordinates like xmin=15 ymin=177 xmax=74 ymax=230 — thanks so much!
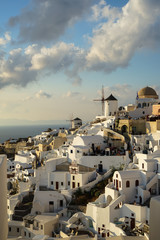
xmin=0 ymin=42 xmax=85 ymax=88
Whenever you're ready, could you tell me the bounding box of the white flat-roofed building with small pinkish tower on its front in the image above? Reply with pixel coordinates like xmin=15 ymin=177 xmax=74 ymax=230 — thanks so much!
xmin=36 ymin=161 xmax=97 ymax=190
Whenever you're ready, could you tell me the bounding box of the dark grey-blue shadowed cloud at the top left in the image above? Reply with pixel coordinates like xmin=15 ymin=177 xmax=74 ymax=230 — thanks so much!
xmin=9 ymin=0 xmax=93 ymax=42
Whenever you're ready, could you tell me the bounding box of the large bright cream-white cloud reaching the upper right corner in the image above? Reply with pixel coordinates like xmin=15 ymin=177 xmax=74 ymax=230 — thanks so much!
xmin=86 ymin=0 xmax=160 ymax=72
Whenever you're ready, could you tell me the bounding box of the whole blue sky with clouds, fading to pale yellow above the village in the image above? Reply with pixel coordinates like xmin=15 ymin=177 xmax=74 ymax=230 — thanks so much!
xmin=0 ymin=0 xmax=160 ymax=125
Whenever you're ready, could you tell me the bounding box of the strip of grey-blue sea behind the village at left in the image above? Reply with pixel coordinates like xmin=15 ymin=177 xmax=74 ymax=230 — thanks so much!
xmin=0 ymin=124 xmax=69 ymax=143
